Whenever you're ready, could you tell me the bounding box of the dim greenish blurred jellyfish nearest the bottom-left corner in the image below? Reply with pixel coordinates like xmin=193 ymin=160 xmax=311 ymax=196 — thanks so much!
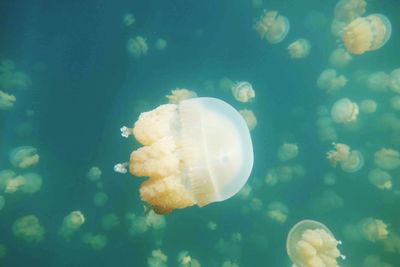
xmin=12 ymin=215 xmax=45 ymax=242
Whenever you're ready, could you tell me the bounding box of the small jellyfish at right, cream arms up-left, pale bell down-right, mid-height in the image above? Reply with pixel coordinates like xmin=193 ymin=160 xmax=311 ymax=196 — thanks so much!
xmin=327 ymin=143 xmax=364 ymax=172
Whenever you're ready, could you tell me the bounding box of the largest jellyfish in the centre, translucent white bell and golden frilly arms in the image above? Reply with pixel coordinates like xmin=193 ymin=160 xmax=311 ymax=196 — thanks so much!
xmin=116 ymin=98 xmax=253 ymax=214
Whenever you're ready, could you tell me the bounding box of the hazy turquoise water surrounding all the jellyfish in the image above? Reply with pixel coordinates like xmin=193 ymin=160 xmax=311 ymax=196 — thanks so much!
xmin=0 ymin=0 xmax=400 ymax=267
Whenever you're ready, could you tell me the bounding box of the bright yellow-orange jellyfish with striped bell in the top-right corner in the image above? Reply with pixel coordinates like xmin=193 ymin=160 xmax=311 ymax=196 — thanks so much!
xmin=342 ymin=14 xmax=392 ymax=55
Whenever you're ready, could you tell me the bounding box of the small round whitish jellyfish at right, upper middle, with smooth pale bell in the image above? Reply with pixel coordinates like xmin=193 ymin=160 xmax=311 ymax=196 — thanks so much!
xmin=331 ymin=98 xmax=358 ymax=124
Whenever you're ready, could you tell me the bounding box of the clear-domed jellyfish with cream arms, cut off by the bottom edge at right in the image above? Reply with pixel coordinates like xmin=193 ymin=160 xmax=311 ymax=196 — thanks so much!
xmin=286 ymin=220 xmax=345 ymax=267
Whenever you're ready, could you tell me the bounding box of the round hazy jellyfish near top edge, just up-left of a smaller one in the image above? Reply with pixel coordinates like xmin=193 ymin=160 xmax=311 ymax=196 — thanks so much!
xmin=254 ymin=11 xmax=290 ymax=44
